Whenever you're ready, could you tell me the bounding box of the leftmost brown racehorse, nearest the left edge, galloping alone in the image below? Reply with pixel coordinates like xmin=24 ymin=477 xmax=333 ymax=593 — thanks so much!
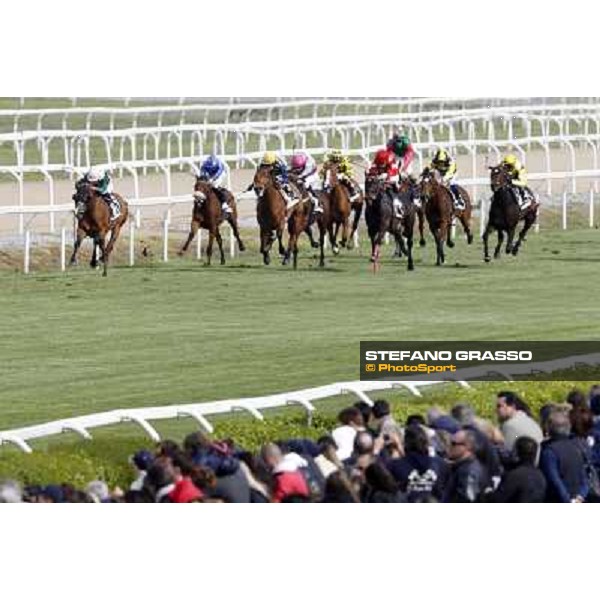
xmin=71 ymin=180 xmax=129 ymax=277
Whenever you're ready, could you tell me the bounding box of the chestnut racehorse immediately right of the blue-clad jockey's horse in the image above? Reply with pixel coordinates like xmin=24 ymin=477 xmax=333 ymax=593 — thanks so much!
xmin=253 ymin=165 xmax=287 ymax=266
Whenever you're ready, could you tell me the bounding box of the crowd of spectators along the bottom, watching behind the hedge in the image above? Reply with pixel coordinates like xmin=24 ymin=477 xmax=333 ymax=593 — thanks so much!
xmin=0 ymin=387 xmax=600 ymax=503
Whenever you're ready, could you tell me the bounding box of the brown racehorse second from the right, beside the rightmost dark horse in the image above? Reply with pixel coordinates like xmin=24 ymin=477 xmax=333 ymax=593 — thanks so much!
xmin=419 ymin=169 xmax=454 ymax=267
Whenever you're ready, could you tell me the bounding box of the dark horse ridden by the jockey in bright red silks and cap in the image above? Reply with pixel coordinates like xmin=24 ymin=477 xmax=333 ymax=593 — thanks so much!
xmin=365 ymin=175 xmax=417 ymax=271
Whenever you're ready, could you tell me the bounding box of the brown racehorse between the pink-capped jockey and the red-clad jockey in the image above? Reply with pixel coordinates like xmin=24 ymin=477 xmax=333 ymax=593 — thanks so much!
xmin=317 ymin=162 xmax=362 ymax=267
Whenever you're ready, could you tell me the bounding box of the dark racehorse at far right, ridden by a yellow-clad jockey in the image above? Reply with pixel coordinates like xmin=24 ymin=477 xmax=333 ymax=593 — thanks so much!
xmin=483 ymin=167 xmax=540 ymax=263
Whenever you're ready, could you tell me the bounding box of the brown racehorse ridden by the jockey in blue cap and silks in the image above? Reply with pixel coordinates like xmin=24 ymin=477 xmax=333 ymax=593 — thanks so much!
xmin=178 ymin=178 xmax=246 ymax=266
